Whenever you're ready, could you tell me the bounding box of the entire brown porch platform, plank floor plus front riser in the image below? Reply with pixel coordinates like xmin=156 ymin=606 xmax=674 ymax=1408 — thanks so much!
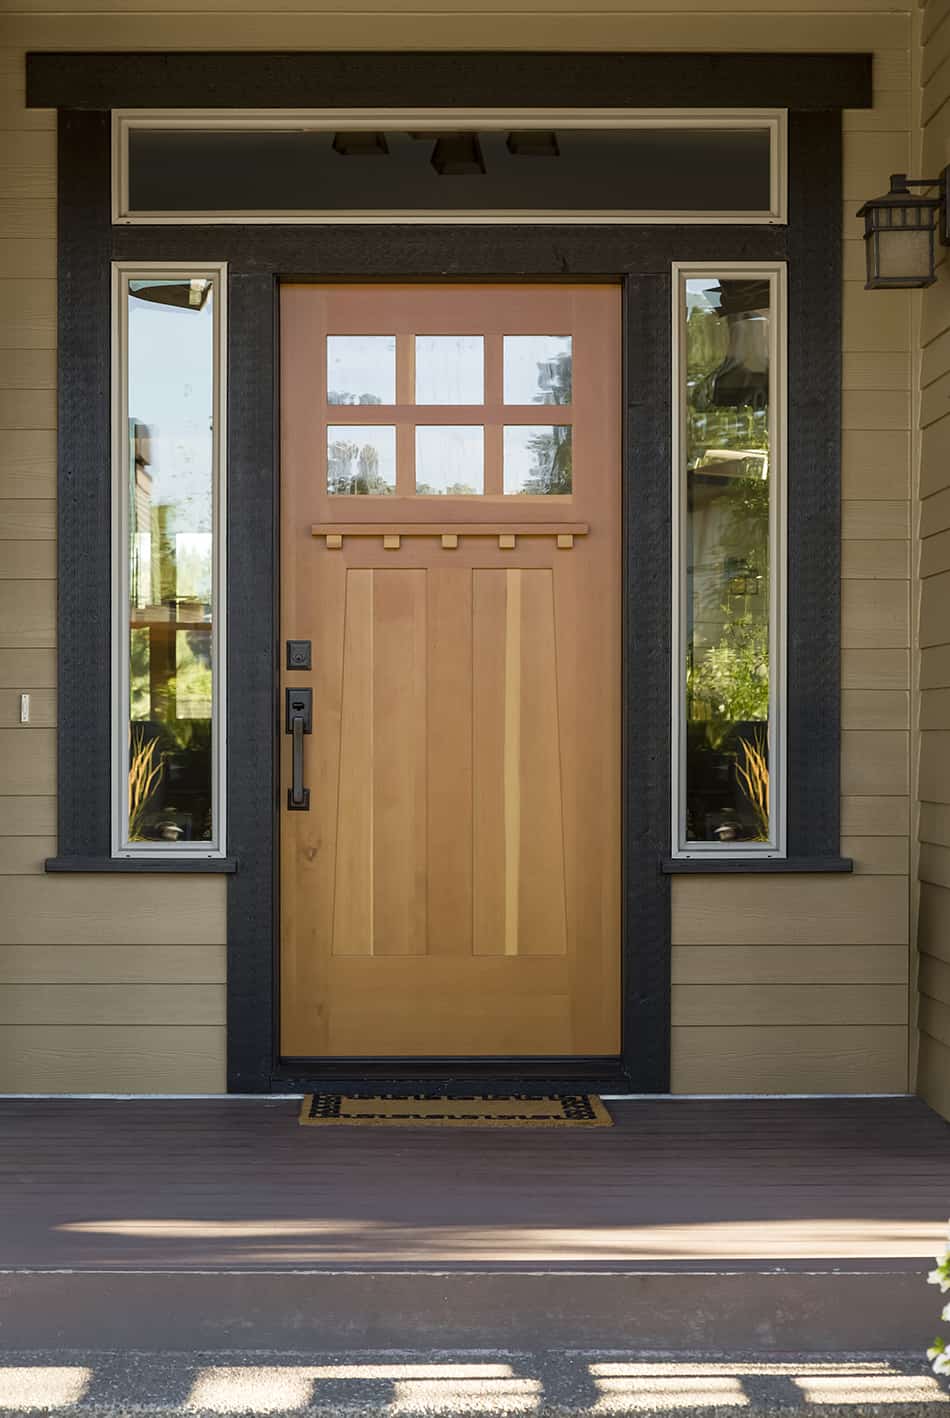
xmin=0 ymin=1099 xmax=950 ymax=1349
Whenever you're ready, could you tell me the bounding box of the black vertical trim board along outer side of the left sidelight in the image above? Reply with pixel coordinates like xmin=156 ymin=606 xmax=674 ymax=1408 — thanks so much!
xmin=57 ymin=113 xmax=112 ymax=858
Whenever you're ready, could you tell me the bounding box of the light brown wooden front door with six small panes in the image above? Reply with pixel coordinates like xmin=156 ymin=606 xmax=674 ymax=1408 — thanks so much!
xmin=281 ymin=285 xmax=621 ymax=1058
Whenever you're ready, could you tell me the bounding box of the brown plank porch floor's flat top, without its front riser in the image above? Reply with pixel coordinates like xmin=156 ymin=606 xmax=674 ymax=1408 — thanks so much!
xmin=0 ymin=1099 xmax=950 ymax=1271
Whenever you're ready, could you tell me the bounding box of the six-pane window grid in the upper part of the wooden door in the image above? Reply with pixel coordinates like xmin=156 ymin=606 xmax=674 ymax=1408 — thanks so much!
xmin=325 ymin=333 xmax=574 ymax=498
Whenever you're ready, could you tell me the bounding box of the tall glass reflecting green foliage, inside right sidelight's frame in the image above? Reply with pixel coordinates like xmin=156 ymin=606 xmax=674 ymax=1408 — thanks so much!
xmin=685 ymin=277 xmax=771 ymax=842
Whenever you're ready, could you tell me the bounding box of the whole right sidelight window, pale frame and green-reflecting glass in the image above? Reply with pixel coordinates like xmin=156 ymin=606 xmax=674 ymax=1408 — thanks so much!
xmin=674 ymin=267 xmax=786 ymax=856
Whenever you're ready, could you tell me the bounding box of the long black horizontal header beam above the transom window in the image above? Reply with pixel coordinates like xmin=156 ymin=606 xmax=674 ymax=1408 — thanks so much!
xmin=27 ymin=51 xmax=872 ymax=109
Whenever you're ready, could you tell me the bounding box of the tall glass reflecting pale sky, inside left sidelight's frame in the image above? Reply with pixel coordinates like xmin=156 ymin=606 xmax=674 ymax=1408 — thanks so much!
xmin=126 ymin=277 xmax=220 ymax=844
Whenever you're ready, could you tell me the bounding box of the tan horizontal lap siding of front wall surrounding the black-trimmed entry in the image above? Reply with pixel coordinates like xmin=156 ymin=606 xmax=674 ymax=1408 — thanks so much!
xmin=0 ymin=0 xmax=924 ymax=1092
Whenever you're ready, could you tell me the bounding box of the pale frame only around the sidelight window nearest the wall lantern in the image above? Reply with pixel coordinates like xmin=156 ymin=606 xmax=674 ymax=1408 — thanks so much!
xmin=671 ymin=261 xmax=788 ymax=861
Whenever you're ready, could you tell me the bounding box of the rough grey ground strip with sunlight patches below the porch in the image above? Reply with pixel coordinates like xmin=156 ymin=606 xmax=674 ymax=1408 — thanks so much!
xmin=0 ymin=1349 xmax=950 ymax=1418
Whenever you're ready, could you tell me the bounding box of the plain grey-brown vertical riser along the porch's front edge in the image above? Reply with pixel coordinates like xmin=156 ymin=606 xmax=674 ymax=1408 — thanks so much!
xmin=0 ymin=1259 xmax=940 ymax=1354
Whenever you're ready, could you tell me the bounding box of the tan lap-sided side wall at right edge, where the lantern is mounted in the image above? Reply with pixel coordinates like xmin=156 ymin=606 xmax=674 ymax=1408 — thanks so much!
xmin=916 ymin=0 xmax=950 ymax=1116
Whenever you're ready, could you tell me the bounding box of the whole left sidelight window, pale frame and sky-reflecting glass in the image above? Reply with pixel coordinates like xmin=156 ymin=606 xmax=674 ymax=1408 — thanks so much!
xmin=113 ymin=265 xmax=224 ymax=856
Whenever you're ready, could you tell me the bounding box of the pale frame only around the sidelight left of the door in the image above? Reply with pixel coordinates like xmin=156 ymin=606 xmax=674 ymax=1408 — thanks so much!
xmin=112 ymin=261 xmax=227 ymax=861
